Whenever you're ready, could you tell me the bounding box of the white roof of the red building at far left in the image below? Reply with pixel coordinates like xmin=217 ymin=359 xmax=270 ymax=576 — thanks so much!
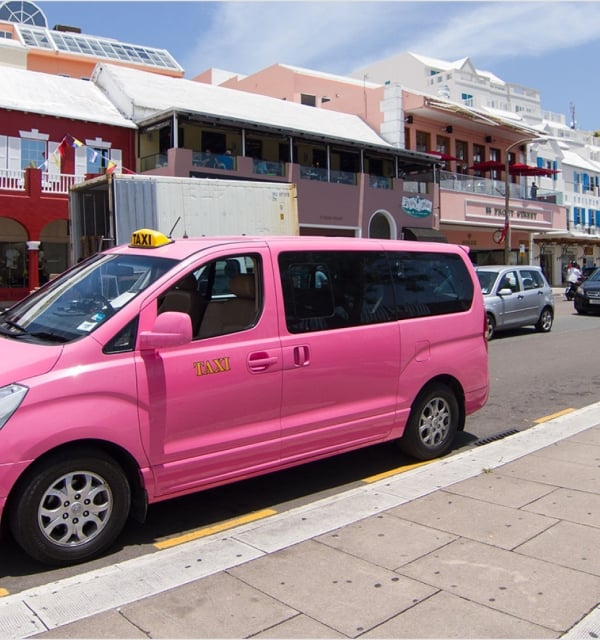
xmin=0 ymin=65 xmax=137 ymax=129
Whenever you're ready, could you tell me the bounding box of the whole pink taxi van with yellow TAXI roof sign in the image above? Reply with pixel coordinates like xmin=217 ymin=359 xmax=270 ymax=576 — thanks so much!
xmin=0 ymin=230 xmax=488 ymax=565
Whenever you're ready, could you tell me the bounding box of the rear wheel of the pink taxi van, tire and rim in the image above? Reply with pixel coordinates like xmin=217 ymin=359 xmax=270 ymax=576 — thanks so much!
xmin=398 ymin=383 xmax=459 ymax=460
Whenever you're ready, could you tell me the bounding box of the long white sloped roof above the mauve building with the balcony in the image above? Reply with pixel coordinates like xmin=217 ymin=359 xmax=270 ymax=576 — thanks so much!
xmin=92 ymin=63 xmax=395 ymax=150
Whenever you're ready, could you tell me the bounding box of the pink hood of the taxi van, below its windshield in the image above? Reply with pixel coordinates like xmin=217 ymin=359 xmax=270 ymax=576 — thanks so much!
xmin=0 ymin=336 xmax=63 ymax=387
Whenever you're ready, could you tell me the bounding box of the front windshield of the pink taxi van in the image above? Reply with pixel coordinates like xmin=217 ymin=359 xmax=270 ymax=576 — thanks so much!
xmin=0 ymin=254 xmax=176 ymax=343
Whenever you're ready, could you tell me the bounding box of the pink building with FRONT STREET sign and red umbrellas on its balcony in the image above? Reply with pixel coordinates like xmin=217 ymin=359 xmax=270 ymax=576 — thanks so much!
xmin=195 ymin=64 xmax=566 ymax=284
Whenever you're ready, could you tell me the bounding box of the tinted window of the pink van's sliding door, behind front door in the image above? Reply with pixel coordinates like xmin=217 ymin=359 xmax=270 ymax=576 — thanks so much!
xmin=279 ymin=251 xmax=395 ymax=333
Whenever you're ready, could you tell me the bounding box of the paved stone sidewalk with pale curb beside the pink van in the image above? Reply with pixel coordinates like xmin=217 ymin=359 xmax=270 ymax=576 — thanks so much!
xmin=0 ymin=403 xmax=600 ymax=638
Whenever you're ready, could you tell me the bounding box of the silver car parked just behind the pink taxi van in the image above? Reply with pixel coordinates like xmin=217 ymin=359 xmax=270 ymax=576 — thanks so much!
xmin=475 ymin=265 xmax=554 ymax=340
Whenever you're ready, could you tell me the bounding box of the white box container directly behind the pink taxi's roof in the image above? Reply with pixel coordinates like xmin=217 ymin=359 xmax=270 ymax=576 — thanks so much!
xmin=69 ymin=174 xmax=298 ymax=262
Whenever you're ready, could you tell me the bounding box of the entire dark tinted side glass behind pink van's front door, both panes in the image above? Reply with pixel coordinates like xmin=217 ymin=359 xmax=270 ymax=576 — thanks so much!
xmin=279 ymin=251 xmax=474 ymax=333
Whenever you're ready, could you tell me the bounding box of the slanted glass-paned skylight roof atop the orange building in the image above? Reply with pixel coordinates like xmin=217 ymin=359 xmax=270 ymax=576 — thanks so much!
xmin=15 ymin=25 xmax=182 ymax=71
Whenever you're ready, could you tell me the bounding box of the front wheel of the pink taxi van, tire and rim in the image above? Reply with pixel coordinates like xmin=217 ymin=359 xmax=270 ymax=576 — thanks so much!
xmin=8 ymin=449 xmax=131 ymax=566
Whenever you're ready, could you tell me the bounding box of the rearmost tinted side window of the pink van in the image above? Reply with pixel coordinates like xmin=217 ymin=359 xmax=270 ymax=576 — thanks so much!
xmin=389 ymin=251 xmax=474 ymax=319
